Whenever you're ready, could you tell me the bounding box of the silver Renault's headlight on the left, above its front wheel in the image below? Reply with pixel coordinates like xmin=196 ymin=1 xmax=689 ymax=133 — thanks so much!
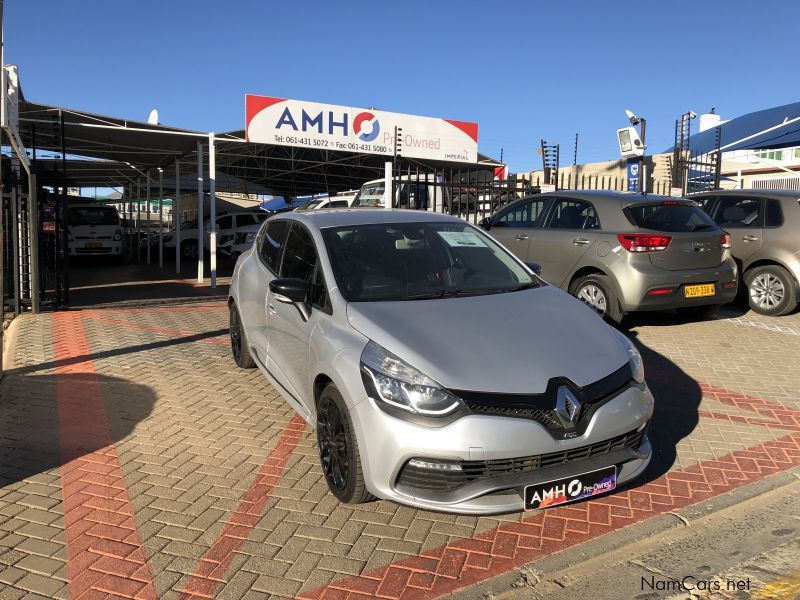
xmin=361 ymin=342 xmax=462 ymax=417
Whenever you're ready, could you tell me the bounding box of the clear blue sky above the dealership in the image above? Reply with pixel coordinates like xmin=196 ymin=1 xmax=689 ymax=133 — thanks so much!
xmin=5 ymin=0 xmax=800 ymax=171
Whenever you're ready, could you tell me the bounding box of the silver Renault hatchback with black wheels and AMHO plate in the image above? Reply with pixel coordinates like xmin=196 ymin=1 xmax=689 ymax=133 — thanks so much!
xmin=229 ymin=209 xmax=653 ymax=514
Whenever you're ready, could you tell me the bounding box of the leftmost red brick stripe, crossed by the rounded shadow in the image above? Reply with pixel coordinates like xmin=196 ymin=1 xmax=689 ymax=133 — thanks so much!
xmin=53 ymin=312 xmax=156 ymax=599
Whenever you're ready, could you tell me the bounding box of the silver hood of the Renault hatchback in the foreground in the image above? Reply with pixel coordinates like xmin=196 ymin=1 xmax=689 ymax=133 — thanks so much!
xmin=347 ymin=286 xmax=628 ymax=394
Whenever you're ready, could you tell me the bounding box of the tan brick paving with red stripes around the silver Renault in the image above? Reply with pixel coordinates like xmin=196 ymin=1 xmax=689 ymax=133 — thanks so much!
xmin=0 ymin=268 xmax=800 ymax=599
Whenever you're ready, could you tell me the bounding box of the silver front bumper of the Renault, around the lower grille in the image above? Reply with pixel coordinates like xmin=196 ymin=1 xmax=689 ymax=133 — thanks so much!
xmin=351 ymin=385 xmax=653 ymax=515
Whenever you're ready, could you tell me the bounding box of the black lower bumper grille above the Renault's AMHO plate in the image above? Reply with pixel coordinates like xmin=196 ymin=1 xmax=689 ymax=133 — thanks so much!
xmin=397 ymin=428 xmax=647 ymax=492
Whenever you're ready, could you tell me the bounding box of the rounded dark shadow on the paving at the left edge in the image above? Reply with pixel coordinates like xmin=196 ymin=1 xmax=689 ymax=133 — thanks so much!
xmin=0 ymin=373 xmax=156 ymax=489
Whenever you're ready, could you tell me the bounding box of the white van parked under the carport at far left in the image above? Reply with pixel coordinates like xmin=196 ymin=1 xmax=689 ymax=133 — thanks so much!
xmin=67 ymin=204 xmax=122 ymax=260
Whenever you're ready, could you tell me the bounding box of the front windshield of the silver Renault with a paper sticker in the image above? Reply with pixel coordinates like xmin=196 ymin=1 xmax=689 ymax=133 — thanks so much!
xmin=323 ymin=222 xmax=539 ymax=302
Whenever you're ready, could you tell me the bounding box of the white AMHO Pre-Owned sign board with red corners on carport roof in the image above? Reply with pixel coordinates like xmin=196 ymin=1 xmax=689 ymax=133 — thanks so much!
xmin=245 ymin=94 xmax=478 ymax=163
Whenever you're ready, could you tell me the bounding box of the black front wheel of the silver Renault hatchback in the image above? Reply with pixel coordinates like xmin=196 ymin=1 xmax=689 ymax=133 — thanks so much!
xmin=317 ymin=383 xmax=375 ymax=504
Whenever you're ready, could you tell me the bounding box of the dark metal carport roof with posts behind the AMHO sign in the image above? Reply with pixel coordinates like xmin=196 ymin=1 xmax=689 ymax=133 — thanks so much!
xmin=6 ymin=97 xmax=502 ymax=308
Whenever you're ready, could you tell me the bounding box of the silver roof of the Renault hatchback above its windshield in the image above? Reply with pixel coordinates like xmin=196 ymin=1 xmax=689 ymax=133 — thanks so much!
xmin=270 ymin=208 xmax=466 ymax=229
